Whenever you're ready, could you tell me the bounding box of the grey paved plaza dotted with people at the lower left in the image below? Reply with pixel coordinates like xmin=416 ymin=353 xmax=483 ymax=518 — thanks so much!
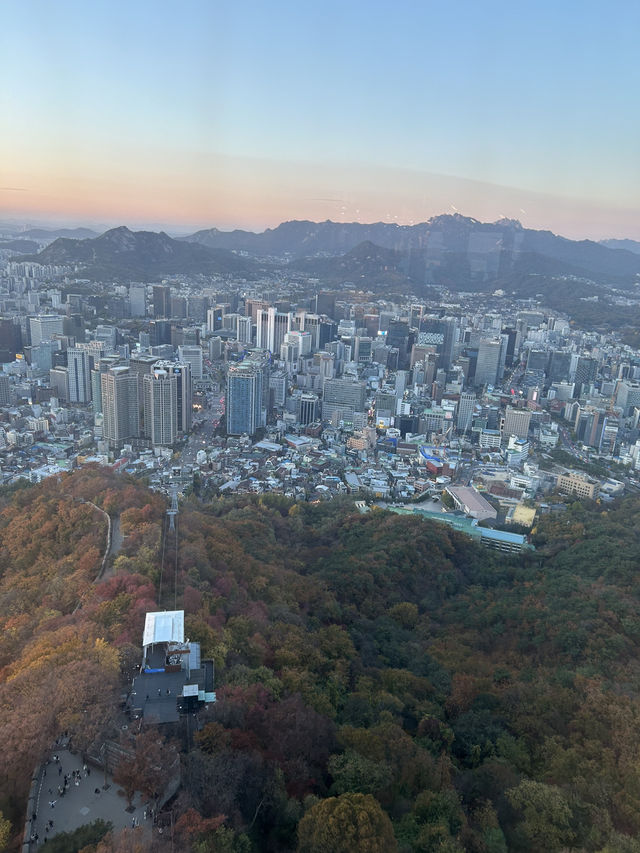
xmin=29 ymin=748 xmax=151 ymax=850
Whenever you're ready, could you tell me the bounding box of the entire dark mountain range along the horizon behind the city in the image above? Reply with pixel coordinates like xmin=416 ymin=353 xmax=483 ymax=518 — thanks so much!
xmin=16 ymin=214 xmax=640 ymax=290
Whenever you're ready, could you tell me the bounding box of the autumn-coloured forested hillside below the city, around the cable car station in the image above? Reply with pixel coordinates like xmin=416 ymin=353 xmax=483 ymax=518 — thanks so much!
xmin=0 ymin=469 xmax=640 ymax=853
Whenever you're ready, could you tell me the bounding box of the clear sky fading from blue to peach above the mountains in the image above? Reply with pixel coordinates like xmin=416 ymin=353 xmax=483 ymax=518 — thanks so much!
xmin=0 ymin=0 xmax=640 ymax=240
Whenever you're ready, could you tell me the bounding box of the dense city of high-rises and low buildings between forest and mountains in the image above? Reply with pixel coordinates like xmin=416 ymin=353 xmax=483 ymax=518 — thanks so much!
xmin=0 ymin=230 xmax=640 ymax=550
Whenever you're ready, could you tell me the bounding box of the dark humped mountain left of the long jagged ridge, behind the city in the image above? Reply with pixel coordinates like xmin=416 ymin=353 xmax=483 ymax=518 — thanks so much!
xmin=20 ymin=225 xmax=255 ymax=280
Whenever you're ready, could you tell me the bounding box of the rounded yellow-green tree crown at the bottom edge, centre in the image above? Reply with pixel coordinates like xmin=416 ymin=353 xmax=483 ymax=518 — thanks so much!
xmin=298 ymin=794 xmax=398 ymax=853
